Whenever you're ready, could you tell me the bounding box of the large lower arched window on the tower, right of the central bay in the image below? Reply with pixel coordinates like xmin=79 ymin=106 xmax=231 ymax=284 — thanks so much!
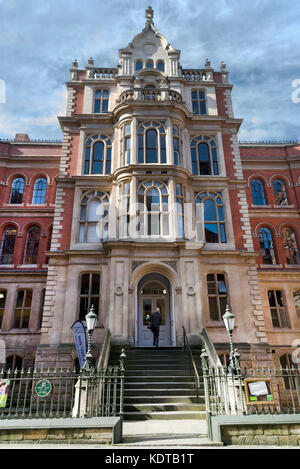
xmin=195 ymin=192 xmax=227 ymax=243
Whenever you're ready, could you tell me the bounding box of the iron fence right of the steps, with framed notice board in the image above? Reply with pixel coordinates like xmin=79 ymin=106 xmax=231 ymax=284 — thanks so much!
xmin=201 ymin=352 xmax=300 ymax=415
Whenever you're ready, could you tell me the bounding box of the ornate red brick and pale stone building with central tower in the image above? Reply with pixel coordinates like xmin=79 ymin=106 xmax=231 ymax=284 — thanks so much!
xmin=0 ymin=8 xmax=300 ymax=366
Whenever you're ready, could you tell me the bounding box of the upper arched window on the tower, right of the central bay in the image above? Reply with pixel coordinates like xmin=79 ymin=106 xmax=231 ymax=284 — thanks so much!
xmin=191 ymin=137 xmax=219 ymax=176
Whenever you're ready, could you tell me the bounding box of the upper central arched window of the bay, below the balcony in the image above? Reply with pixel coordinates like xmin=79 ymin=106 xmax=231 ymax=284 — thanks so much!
xmin=138 ymin=122 xmax=167 ymax=164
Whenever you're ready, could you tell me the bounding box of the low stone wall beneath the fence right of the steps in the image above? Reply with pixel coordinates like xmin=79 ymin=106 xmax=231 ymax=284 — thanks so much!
xmin=221 ymin=423 xmax=300 ymax=446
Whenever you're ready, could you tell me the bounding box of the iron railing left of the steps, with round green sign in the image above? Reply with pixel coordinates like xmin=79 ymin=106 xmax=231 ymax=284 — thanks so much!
xmin=0 ymin=361 xmax=125 ymax=419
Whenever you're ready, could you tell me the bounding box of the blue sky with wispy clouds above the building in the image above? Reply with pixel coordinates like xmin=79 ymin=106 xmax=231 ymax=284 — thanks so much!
xmin=0 ymin=0 xmax=300 ymax=141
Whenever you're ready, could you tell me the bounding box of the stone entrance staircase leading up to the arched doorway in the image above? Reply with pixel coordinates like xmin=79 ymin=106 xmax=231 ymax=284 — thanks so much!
xmin=109 ymin=346 xmax=206 ymax=423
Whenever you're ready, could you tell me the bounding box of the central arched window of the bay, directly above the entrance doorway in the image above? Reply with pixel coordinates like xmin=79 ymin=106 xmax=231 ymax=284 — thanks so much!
xmin=137 ymin=181 xmax=169 ymax=237
